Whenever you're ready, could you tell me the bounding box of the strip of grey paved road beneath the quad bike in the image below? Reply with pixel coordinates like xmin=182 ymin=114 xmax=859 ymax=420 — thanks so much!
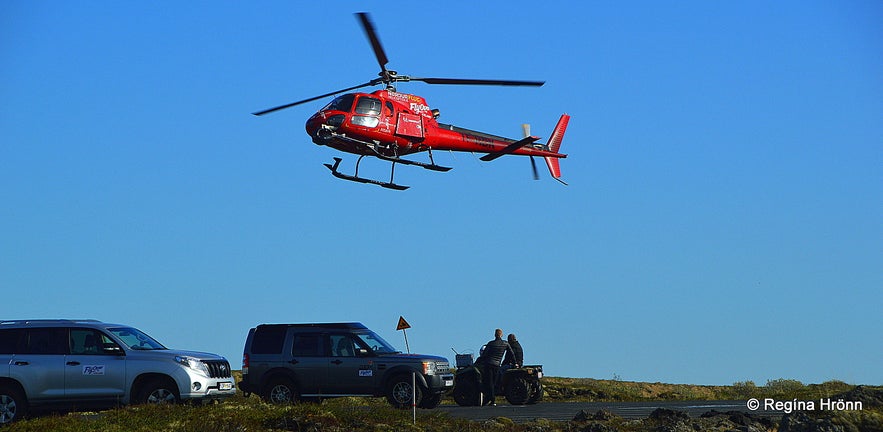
xmin=436 ymin=401 xmax=782 ymax=423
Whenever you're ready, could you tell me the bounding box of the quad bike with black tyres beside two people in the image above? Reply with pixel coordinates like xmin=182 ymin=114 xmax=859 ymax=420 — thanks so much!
xmin=452 ymin=354 xmax=543 ymax=406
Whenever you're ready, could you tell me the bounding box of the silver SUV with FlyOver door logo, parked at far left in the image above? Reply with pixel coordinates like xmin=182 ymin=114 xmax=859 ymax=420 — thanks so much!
xmin=0 ymin=320 xmax=236 ymax=424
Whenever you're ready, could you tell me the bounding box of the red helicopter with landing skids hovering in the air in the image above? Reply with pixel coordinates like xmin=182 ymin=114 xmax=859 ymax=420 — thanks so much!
xmin=253 ymin=13 xmax=570 ymax=190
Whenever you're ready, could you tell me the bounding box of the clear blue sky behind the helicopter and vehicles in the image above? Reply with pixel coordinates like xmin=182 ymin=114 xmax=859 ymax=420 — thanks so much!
xmin=0 ymin=1 xmax=883 ymax=384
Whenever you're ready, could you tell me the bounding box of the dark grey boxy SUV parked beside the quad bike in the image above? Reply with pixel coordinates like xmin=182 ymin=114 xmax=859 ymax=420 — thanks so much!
xmin=239 ymin=323 xmax=454 ymax=408
